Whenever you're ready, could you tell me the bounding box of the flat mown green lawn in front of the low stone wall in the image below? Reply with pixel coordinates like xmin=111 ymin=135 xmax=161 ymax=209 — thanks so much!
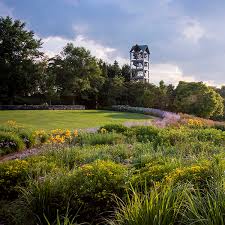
xmin=0 ymin=110 xmax=152 ymax=129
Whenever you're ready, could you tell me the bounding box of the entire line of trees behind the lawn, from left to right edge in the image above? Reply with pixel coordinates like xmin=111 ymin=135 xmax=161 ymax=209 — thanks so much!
xmin=0 ymin=17 xmax=225 ymax=118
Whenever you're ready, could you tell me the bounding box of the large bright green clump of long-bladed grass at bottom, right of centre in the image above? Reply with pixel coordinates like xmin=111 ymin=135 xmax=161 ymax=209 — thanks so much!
xmin=109 ymin=186 xmax=184 ymax=225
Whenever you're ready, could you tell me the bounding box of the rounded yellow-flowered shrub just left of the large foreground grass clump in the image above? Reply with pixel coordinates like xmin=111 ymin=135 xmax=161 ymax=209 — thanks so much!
xmin=65 ymin=160 xmax=129 ymax=221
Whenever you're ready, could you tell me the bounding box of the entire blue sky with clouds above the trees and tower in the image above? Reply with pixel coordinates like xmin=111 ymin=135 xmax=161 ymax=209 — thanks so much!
xmin=0 ymin=0 xmax=225 ymax=85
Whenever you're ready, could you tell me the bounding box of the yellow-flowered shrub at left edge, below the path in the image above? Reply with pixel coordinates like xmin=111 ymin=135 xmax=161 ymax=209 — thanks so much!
xmin=0 ymin=159 xmax=29 ymax=199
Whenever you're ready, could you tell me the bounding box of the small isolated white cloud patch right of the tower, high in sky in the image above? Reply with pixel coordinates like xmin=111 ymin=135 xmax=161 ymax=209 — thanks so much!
xmin=182 ymin=19 xmax=205 ymax=43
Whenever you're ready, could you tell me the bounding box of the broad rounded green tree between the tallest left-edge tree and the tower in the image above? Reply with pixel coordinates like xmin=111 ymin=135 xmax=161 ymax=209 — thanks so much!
xmin=53 ymin=43 xmax=105 ymax=105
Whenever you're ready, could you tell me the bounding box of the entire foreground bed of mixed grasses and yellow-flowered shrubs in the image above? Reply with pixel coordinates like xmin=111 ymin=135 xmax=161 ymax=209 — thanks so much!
xmin=3 ymin=121 xmax=225 ymax=225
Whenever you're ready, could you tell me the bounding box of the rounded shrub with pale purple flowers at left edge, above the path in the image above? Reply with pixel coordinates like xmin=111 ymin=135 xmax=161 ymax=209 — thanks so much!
xmin=0 ymin=131 xmax=25 ymax=155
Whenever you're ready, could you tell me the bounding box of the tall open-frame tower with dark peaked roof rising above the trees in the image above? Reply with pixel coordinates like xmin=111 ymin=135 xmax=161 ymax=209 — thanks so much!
xmin=130 ymin=44 xmax=150 ymax=83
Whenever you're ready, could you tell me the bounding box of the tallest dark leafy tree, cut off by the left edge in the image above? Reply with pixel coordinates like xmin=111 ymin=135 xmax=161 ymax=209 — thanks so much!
xmin=0 ymin=17 xmax=42 ymax=104
